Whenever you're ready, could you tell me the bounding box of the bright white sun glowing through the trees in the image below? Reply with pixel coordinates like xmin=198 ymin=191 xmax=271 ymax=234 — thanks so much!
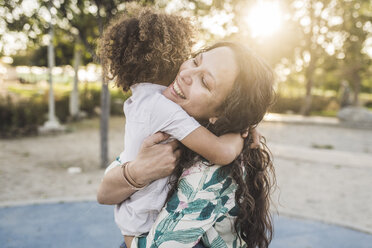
xmin=245 ymin=1 xmax=282 ymax=37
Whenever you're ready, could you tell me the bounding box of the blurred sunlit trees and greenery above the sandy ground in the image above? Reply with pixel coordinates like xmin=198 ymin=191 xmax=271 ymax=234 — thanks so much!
xmin=0 ymin=0 xmax=372 ymax=140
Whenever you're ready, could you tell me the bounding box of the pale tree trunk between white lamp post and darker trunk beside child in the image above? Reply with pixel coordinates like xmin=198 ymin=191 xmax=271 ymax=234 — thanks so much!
xmin=70 ymin=48 xmax=81 ymax=120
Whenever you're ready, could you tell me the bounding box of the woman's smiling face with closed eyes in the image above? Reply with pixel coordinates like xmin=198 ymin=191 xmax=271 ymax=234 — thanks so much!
xmin=163 ymin=47 xmax=239 ymax=120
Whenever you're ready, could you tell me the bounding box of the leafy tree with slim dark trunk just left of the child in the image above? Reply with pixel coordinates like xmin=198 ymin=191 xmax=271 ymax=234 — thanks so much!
xmin=0 ymin=0 xmax=154 ymax=168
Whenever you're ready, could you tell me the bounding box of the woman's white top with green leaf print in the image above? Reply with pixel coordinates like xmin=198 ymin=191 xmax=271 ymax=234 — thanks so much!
xmin=132 ymin=162 xmax=246 ymax=248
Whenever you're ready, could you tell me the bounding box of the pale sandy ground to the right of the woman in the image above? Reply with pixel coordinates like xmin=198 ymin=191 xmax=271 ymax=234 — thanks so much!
xmin=260 ymin=123 xmax=372 ymax=233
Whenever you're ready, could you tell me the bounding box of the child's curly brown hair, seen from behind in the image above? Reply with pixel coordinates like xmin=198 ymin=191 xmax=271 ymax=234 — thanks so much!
xmin=98 ymin=8 xmax=194 ymax=90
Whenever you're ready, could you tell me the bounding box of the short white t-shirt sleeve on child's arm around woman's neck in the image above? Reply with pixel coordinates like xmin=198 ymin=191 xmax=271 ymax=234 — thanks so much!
xmin=149 ymin=94 xmax=200 ymax=140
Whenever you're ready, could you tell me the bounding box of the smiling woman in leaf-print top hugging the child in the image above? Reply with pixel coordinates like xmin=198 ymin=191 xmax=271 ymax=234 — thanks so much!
xmin=98 ymin=42 xmax=273 ymax=247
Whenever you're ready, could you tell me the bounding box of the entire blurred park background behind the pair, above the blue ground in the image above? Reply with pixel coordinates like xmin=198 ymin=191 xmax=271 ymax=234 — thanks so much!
xmin=0 ymin=0 xmax=372 ymax=247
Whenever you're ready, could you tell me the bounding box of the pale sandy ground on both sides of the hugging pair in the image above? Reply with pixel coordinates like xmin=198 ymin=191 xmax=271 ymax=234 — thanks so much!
xmin=0 ymin=117 xmax=372 ymax=233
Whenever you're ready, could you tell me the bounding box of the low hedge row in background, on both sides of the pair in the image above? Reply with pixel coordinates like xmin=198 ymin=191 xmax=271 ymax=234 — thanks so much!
xmin=0 ymin=84 xmax=348 ymax=137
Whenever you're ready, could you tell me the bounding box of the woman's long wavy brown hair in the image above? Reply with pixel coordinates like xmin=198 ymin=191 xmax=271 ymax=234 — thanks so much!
xmin=168 ymin=42 xmax=276 ymax=248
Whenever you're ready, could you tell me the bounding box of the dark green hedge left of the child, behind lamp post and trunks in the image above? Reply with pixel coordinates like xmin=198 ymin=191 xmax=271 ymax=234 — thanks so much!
xmin=0 ymin=87 xmax=131 ymax=138
